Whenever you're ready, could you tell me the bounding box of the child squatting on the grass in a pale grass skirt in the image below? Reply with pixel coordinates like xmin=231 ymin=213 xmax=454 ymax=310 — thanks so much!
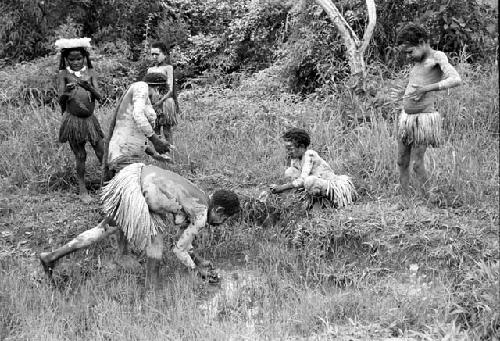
xmin=271 ymin=128 xmax=356 ymax=207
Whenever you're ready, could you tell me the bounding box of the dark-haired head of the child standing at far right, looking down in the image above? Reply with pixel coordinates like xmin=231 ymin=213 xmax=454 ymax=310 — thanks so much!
xmin=397 ymin=23 xmax=430 ymax=62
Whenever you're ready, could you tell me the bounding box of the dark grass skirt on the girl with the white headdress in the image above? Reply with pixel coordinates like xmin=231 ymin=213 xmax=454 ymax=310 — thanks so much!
xmin=59 ymin=112 xmax=104 ymax=145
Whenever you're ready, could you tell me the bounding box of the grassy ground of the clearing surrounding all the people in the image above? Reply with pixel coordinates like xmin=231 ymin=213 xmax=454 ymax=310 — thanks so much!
xmin=0 ymin=59 xmax=500 ymax=340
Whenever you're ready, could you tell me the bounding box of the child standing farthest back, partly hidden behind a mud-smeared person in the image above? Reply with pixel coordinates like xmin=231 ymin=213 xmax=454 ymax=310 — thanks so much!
xmin=147 ymin=42 xmax=179 ymax=144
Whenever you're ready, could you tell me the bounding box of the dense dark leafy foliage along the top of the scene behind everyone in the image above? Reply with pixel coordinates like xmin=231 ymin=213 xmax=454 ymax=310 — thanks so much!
xmin=0 ymin=0 xmax=498 ymax=93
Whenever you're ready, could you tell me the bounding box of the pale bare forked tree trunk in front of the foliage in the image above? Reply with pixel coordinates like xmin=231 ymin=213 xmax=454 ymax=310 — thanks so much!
xmin=316 ymin=0 xmax=377 ymax=92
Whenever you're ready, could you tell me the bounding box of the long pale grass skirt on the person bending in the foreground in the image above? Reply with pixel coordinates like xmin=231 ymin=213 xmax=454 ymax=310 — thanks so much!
xmin=101 ymin=163 xmax=168 ymax=250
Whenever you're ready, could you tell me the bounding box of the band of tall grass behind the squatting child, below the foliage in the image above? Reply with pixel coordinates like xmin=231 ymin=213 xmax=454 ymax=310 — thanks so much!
xmin=0 ymin=65 xmax=499 ymax=203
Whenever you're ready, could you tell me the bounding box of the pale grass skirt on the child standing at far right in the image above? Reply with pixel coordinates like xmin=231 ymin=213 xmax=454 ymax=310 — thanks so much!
xmin=398 ymin=110 xmax=442 ymax=147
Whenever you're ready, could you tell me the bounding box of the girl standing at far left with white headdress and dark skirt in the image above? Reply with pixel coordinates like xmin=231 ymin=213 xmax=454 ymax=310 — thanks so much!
xmin=55 ymin=38 xmax=104 ymax=203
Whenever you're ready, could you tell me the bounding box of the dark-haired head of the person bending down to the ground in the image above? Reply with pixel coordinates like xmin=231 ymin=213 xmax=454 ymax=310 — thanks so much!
xmin=207 ymin=189 xmax=240 ymax=225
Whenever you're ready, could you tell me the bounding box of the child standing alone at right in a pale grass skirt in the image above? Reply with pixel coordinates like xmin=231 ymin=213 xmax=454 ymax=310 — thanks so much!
xmin=393 ymin=24 xmax=461 ymax=196
